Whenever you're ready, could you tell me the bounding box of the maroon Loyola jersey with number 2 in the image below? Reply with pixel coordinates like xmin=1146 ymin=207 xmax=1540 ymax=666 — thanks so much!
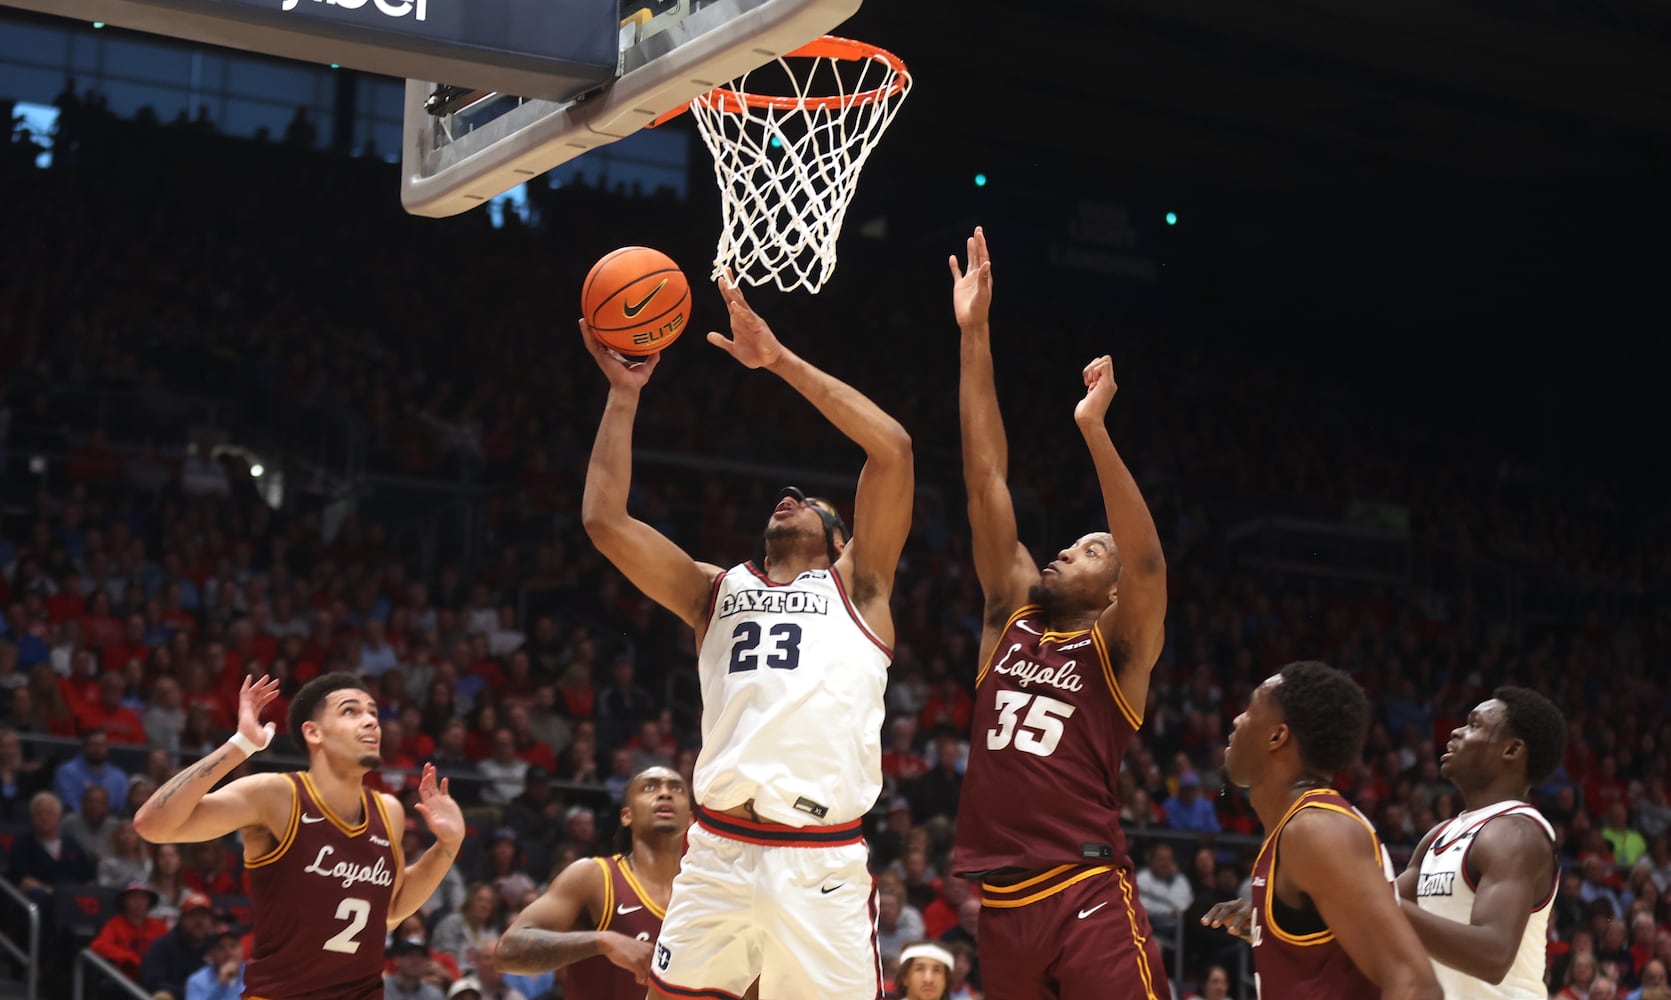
xmin=244 ymin=771 xmax=404 ymax=1000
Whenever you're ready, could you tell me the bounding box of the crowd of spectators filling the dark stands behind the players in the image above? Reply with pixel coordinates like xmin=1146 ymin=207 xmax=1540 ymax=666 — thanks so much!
xmin=0 ymin=88 xmax=1671 ymax=1000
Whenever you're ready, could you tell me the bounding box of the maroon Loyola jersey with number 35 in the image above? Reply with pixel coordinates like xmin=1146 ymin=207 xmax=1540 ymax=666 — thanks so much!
xmin=952 ymin=605 xmax=1143 ymax=875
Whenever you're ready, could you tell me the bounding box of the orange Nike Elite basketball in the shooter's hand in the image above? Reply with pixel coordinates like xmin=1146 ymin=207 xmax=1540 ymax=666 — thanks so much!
xmin=580 ymin=246 xmax=690 ymax=358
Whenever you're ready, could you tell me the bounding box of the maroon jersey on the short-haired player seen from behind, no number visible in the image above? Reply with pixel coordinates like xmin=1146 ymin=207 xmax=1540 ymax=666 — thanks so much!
xmin=1248 ymin=788 xmax=1394 ymax=1000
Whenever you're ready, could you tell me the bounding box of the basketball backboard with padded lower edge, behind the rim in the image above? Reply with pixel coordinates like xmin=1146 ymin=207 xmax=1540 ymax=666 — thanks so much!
xmin=401 ymin=0 xmax=862 ymax=217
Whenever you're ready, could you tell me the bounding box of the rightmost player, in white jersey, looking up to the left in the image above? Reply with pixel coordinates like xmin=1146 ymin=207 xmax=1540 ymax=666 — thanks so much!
xmin=1399 ymin=687 xmax=1566 ymax=1000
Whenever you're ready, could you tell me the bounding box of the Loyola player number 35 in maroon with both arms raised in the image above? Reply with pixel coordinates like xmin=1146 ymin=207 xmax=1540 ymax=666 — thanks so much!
xmin=951 ymin=229 xmax=1171 ymax=1000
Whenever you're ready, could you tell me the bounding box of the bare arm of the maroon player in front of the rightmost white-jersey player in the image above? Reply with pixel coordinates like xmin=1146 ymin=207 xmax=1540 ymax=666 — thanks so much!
xmin=1273 ymin=809 xmax=1444 ymax=1000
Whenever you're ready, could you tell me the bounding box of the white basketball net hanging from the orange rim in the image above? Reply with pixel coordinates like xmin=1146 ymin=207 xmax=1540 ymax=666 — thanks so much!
xmin=690 ymin=38 xmax=911 ymax=293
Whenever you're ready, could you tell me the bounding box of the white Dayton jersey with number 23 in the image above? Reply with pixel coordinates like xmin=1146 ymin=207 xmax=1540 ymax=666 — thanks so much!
xmin=695 ymin=562 xmax=892 ymax=826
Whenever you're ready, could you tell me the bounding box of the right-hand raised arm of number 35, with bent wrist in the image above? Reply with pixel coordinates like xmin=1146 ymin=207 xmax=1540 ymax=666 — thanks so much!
xmin=1073 ymin=355 xmax=1166 ymax=671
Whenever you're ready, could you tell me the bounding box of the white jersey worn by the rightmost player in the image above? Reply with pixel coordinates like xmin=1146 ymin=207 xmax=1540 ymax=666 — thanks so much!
xmin=1415 ymin=799 xmax=1559 ymax=1000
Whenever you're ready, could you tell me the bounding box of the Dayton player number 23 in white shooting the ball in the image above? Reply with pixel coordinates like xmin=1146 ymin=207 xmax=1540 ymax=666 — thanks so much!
xmin=582 ymin=276 xmax=912 ymax=1000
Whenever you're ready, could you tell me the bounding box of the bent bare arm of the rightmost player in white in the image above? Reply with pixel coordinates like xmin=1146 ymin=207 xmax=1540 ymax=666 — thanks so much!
xmin=1400 ymin=816 xmax=1556 ymax=983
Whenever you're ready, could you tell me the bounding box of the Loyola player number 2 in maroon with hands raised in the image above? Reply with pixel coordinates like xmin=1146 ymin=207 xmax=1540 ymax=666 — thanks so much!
xmin=134 ymin=674 xmax=465 ymax=1000
